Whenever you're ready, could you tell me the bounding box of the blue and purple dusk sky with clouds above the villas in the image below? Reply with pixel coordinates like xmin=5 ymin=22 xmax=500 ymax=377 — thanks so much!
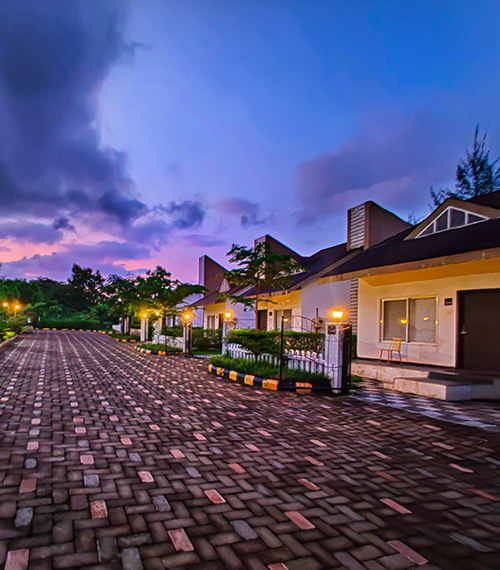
xmin=0 ymin=0 xmax=500 ymax=281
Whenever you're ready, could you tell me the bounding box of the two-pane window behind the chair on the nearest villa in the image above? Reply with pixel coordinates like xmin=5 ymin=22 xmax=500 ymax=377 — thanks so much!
xmin=380 ymin=297 xmax=437 ymax=344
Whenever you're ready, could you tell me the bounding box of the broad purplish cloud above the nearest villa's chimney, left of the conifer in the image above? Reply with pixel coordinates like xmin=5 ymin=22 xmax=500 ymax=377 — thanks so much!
xmin=296 ymin=114 xmax=459 ymax=224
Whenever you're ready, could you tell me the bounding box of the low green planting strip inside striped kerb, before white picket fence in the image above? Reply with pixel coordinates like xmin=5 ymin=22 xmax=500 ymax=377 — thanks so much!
xmin=210 ymin=356 xmax=331 ymax=386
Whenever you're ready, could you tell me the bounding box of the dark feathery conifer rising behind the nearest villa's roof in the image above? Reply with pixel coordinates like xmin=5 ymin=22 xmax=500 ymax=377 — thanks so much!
xmin=430 ymin=126 xmax=500 ymax=206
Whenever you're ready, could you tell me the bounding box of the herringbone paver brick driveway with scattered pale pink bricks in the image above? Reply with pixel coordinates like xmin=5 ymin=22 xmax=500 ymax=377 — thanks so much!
xmin=0 ymin=332 xmax=500 ymax=570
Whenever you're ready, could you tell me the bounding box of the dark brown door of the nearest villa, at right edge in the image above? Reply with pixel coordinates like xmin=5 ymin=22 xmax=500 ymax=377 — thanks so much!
xmin=458 ymin=289 xmax=500 ymax=372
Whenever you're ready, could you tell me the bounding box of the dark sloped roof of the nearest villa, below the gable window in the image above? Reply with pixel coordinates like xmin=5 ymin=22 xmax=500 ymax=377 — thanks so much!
xmin=325 ymin=218 xmax=500 ymax=277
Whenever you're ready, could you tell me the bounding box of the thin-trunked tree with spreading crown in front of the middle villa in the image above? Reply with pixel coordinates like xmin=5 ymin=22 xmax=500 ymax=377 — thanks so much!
xmin=223 ymin=241 xmax=304 ymax=329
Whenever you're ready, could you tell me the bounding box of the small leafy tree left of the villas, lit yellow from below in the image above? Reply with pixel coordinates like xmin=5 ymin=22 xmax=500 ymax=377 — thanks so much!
xmin=137 ymin=265 xmax=206 ymax=327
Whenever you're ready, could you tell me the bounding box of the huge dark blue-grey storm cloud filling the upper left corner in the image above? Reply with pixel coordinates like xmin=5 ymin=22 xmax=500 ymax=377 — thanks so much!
xmin=0 ymin=0 xmax=147 ymax=226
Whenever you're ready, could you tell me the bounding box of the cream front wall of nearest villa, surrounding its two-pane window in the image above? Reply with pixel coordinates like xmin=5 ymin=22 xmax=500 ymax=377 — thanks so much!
xmin=358 ymin=273 xmax=500 ymax=367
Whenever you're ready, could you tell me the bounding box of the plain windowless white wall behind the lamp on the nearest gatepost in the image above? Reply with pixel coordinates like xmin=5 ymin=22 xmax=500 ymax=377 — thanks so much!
xmin=302 ymin=281 xmax=351 ymax=320
